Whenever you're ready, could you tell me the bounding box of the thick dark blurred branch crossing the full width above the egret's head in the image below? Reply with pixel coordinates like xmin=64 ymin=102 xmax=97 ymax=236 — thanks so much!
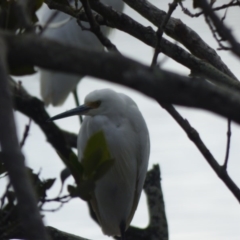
xmin=3 ymin=34 xmax=240 ymax=123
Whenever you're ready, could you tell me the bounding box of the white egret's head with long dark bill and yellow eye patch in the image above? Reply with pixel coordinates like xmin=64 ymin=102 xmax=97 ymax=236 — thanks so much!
xmin=49 ymin=89 xmax=122 ymax=121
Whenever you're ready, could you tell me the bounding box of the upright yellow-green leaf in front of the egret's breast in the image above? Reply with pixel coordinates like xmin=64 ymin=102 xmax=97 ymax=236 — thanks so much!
xmin=81 ymin=131 xmax=113 ymax=179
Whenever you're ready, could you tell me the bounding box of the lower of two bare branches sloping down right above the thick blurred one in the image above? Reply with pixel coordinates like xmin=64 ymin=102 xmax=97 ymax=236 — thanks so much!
xmin=44 ymin=1 xmax=240 ymax=93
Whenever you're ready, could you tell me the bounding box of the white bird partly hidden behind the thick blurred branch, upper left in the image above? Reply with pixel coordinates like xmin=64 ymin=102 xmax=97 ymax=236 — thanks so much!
xmin=40 ymin=0 xmax=124 ymax=106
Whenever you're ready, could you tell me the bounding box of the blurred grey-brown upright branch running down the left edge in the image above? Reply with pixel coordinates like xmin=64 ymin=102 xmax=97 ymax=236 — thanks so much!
xmin=0 ymin=39 xmax=48 ymax=240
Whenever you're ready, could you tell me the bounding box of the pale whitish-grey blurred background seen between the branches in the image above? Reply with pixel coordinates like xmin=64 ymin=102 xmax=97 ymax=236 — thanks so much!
xmin=5 ymin=0 xmax=240 ymax=240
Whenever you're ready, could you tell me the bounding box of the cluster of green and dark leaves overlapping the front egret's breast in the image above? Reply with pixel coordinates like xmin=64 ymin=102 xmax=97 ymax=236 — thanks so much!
xmin=58 ymin=131 xmax=114 ymax=200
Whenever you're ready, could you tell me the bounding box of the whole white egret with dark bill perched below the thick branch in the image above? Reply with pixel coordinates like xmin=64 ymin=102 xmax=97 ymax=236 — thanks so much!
xmin=50 ymin=89 xmax=150 ymax=239
